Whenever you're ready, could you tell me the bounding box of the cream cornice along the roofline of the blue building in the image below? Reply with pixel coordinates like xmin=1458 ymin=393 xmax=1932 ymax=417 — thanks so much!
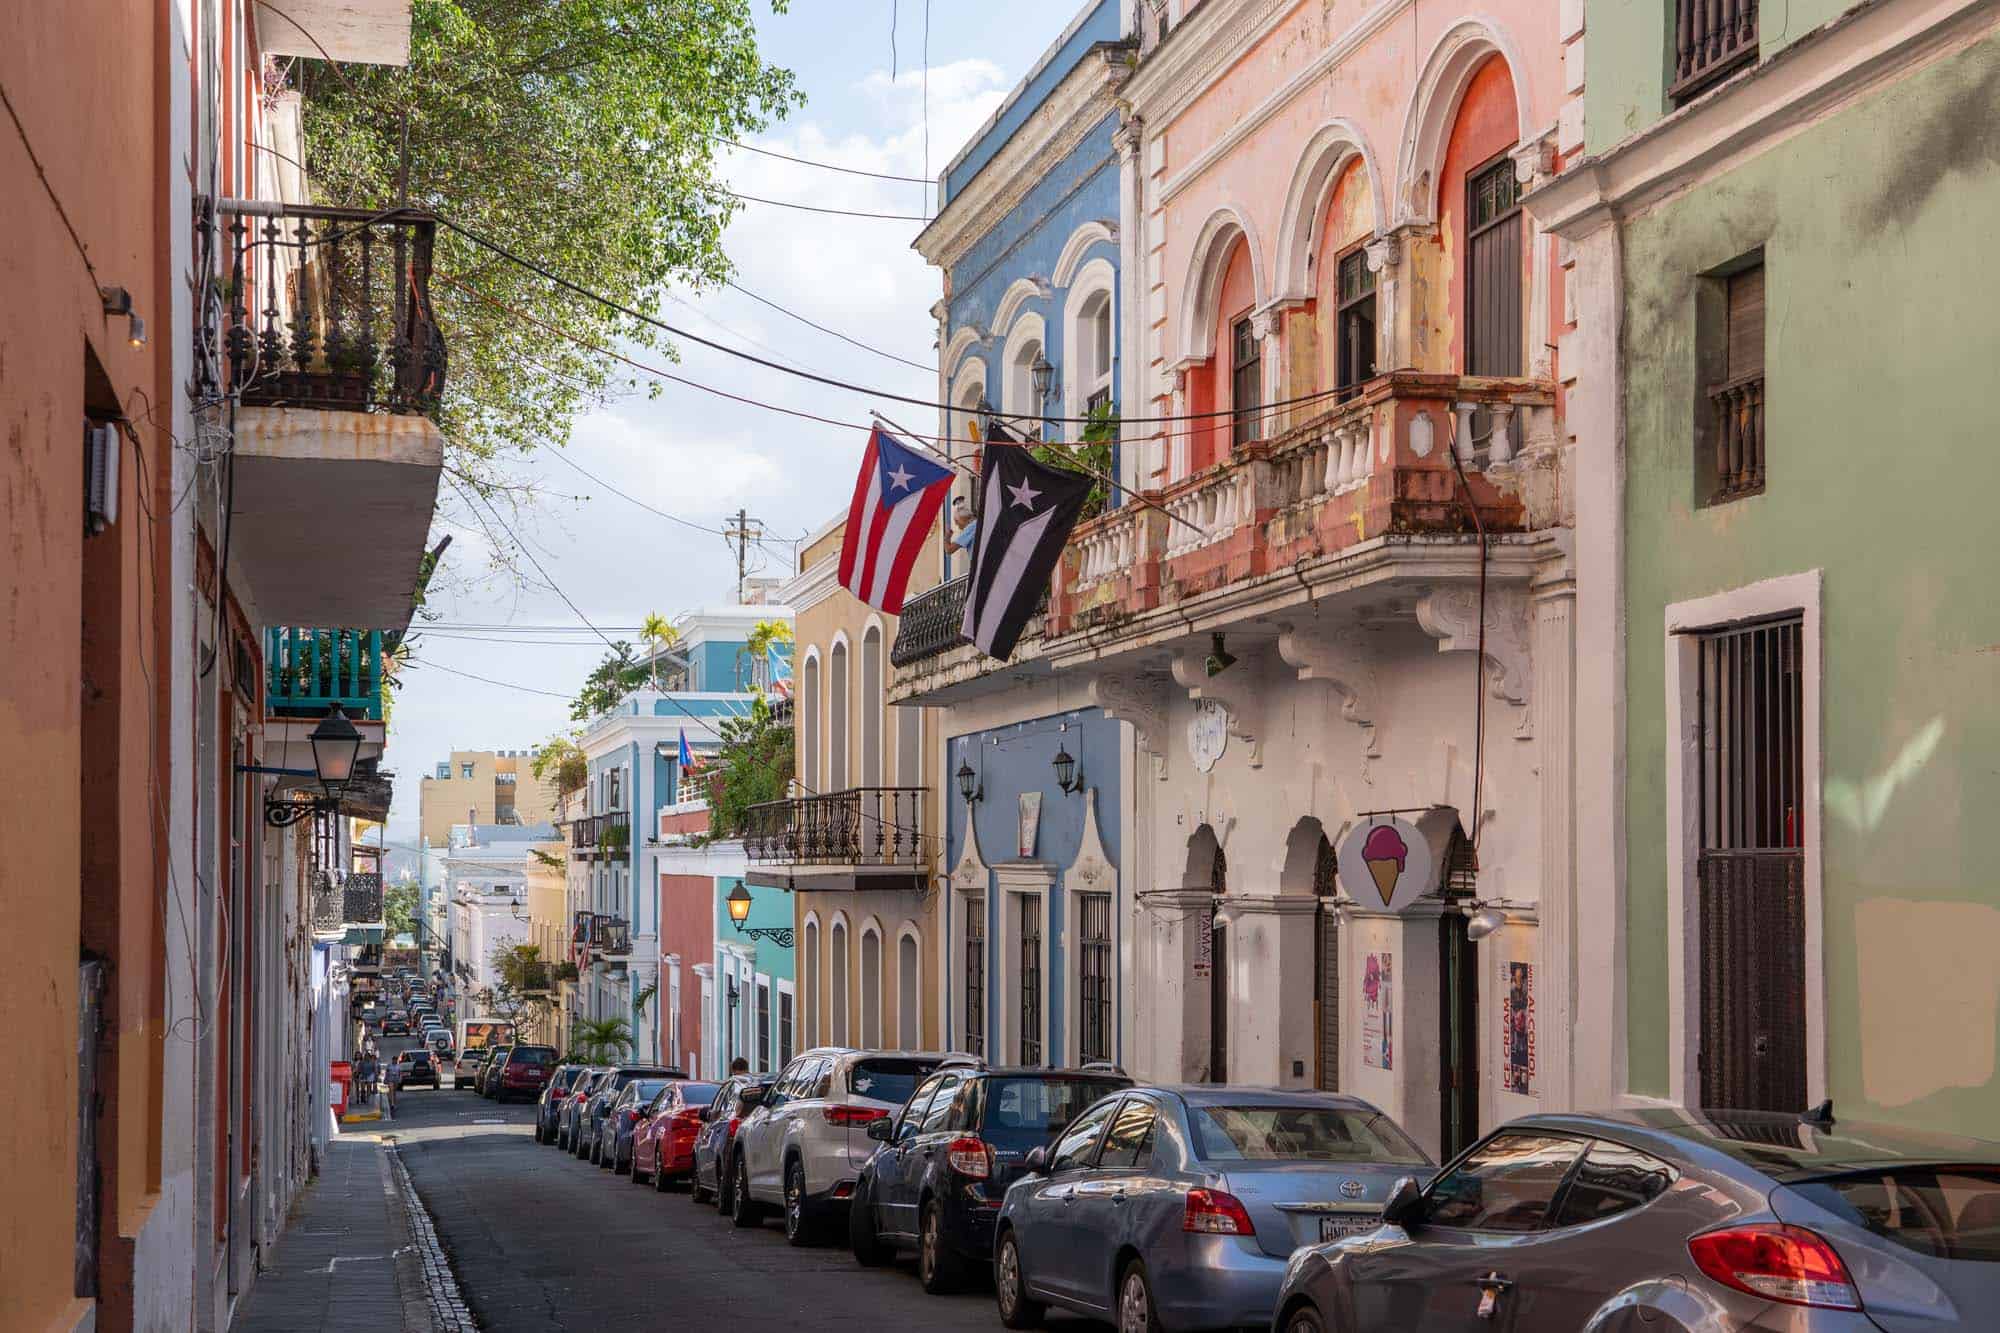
xmin=912 ymin=46 xmax=1130 ymax=268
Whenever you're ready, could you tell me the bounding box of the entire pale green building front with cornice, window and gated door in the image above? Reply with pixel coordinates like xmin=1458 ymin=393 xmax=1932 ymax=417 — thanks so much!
xmin=1528 ymin=0 xmax=2000 ymax=1135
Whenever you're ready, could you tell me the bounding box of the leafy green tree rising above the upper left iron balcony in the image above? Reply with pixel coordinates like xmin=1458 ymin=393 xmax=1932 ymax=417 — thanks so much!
xmin=298 ymin=0 xmax=800 ymax=476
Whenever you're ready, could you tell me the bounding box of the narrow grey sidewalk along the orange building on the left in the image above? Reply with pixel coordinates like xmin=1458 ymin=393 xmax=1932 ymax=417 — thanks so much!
xmin=234 ymin=1121 xmax=450 ymax=1333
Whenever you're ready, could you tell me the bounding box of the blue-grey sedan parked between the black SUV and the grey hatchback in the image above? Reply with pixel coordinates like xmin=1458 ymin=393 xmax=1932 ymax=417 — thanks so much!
xmin=994 ymin=1085 xmax=1432 ymax=1333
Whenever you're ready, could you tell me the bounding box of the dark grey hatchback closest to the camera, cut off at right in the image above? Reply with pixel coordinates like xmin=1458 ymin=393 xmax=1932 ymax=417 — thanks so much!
xmin=1272 ymin=1105 xmax=2000 ymax=1333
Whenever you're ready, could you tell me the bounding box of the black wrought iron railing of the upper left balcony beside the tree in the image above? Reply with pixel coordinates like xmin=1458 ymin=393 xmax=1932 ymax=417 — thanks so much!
xmin=198 ymin=200 xmax=444 ymax=414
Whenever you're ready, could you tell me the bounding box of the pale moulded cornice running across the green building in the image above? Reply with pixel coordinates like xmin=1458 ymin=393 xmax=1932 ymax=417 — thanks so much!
xmin=1522 ymin=0 xmax=2000 ymax=240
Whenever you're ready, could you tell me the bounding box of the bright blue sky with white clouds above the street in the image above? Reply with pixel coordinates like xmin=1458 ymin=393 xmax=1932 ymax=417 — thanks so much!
xmin=382 ymin=0 xmax=1084 ymax=841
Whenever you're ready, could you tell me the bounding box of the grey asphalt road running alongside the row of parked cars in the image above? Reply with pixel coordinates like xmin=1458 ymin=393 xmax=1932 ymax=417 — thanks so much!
xmin=384 ymin=1039 xmax=1094 ymax=1333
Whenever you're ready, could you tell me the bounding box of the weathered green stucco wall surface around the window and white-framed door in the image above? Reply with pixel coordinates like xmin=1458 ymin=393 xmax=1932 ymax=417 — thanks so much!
xmin=1616 ymin=31 xmax=2000 ymax=1133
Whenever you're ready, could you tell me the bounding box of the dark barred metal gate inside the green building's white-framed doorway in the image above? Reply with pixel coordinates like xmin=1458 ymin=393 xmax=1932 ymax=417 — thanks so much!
xmin=1696 ymin=616 xmax=1808 ymax=1111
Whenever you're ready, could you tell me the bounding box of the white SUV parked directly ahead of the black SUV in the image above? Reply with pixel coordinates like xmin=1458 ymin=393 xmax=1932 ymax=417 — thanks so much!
xmin=730 ymin=1047 xmax=976 ymax=1245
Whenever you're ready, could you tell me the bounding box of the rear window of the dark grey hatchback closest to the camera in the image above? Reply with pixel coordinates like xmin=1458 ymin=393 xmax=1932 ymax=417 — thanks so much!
xmin=1792 ymin=1167 xmax=2000 ymax=1263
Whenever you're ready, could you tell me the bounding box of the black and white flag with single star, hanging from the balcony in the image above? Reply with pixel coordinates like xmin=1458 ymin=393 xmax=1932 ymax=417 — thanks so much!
xmin=962 ymin=428 xmax=1092 ymax=660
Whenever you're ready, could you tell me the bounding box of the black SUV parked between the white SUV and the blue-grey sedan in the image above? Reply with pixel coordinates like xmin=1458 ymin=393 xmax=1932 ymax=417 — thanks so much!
xmin=848 ymin=1069 xmax=1132 ymax=1293
